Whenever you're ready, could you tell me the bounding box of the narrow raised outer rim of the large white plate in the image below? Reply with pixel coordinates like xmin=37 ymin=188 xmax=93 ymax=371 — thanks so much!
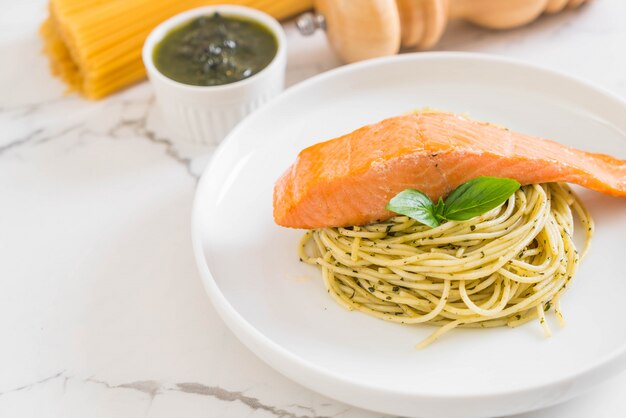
xmin=191 ymin=52 xmax=626 ymax=401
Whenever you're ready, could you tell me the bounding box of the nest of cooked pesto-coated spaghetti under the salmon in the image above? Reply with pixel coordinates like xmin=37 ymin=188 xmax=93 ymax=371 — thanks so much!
xmin=299 ymin=183 xmax=593 ymax=348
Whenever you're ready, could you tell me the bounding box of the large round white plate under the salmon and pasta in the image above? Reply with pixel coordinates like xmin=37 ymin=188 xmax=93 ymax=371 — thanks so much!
xmin=193 ymin=53 xmax=626 ymax=418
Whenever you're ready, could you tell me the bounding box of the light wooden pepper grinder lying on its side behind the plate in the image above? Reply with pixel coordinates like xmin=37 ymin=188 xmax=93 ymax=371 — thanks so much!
xmin=297 ymin=0 xmax=589 ymax=62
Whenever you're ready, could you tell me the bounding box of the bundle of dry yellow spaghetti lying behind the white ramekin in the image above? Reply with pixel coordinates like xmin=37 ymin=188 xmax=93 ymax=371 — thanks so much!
xmin=40 ymin=0 xmax=313 ymax=99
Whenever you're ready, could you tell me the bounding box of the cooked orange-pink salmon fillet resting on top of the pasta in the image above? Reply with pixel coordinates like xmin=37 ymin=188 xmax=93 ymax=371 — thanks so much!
xmin=274 ymin=112 xmax=626 ymax=229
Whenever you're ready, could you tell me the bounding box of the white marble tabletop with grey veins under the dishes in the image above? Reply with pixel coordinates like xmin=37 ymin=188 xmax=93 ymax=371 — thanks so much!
xmin=0 ymin=0 xmax=626 ymax=418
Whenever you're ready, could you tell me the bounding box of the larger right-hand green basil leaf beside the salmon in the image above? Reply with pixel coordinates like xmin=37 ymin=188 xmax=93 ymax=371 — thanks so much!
xmin=443 ymin=176 xmax=520 ymax=221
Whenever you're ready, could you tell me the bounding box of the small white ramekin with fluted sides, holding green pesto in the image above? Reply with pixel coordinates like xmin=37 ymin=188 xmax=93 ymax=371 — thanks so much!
xmin=142 ymin=5 xmax=287 ymax=145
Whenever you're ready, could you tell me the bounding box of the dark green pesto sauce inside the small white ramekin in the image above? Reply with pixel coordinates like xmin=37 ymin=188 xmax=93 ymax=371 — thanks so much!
xmin=153 ymin=13 xmax=278 ymax=86
